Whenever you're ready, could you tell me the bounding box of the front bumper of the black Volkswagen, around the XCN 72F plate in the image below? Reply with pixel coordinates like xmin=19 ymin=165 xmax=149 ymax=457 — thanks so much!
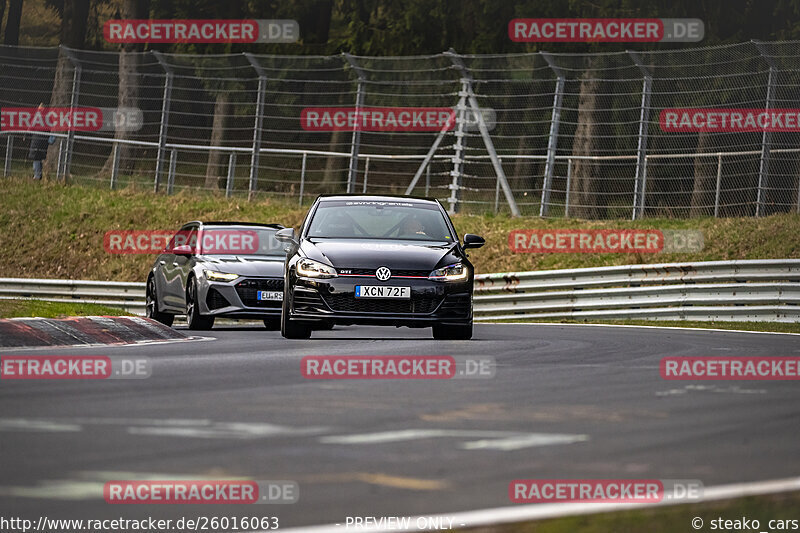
xmin=289 ymin=276 xmax=472 ymax=327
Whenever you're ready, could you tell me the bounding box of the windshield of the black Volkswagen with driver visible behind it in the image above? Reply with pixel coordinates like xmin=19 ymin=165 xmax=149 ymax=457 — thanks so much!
xmin=307 ymin=200 xmax=453 ymax=242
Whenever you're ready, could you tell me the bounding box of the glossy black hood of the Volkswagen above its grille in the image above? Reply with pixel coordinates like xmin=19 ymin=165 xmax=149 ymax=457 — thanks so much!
xmin=302 ymin=239 xmax=461 ymax=270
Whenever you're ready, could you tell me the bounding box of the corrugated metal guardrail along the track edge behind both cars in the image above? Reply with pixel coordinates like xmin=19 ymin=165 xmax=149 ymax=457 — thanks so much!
xmin=0 ymin=259 xmax=800 ymax=322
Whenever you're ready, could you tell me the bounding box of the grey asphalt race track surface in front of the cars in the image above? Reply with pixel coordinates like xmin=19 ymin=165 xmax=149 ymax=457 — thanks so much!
xmin=0 ymin=324 xmax=800 ymax=528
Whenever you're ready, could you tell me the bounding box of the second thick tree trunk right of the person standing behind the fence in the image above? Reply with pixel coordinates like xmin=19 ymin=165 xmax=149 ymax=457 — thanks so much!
xmin=100 ymin=0 xmax=150 ymax=175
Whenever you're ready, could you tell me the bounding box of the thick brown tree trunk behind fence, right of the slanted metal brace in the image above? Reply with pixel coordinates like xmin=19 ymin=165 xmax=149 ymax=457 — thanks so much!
xmin=570 ymin=71 xmax=601 ymax=219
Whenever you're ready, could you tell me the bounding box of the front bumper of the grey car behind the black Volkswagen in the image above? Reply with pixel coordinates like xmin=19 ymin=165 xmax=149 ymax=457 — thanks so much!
xmin=198 ymin=277 xmax=283 ymax=319
